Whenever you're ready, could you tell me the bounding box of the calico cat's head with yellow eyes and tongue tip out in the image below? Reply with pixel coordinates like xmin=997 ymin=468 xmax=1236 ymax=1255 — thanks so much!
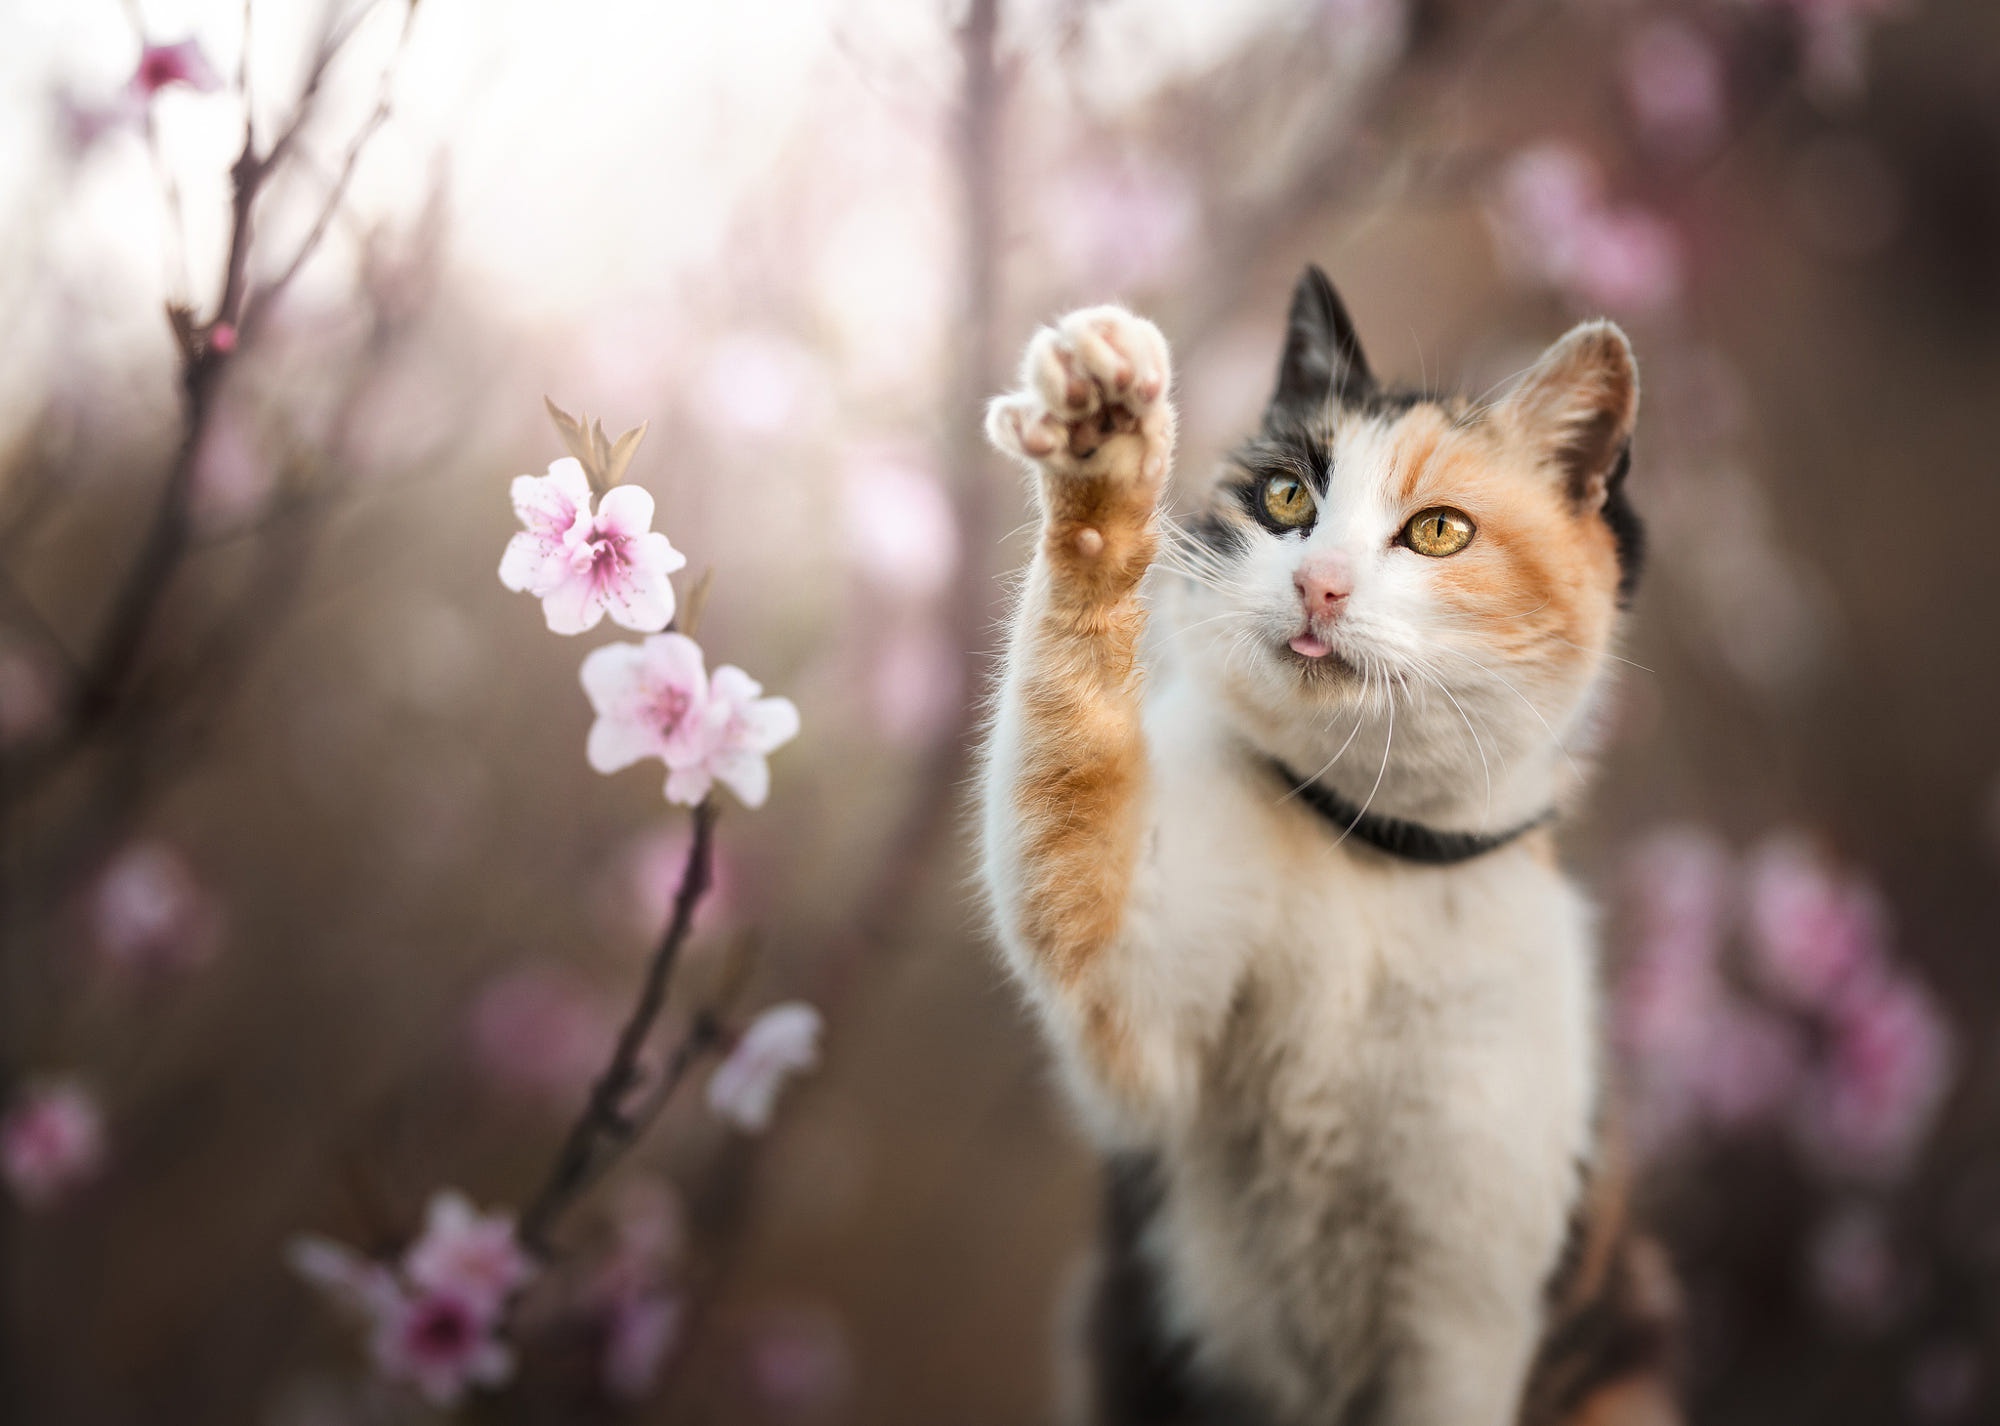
xmin=1168 ymin=268 xmax=1640 ymax=828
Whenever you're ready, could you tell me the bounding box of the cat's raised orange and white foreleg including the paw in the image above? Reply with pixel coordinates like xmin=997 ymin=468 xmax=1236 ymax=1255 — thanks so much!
xmin=984 ymin=306 xmax=1174 ymax=1120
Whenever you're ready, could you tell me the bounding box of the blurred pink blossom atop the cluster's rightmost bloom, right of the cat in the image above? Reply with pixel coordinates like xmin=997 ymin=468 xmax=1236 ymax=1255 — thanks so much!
xmin=1748 ymin=836 xmax=1888 ymax=1008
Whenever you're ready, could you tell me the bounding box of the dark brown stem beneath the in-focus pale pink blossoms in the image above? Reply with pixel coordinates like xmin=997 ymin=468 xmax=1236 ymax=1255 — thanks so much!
xmin=520 ymin=798 xmax=716 ymax=1256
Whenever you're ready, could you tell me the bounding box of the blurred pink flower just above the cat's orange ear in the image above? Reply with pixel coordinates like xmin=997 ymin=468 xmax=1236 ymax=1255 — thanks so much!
xmin=1488 ymin=142 xmax=1680 ymax=314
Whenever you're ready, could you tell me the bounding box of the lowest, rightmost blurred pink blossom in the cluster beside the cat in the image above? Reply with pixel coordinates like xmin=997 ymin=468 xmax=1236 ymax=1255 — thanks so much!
xmin=1798 ymin=972 xmax=1952 ymax=1178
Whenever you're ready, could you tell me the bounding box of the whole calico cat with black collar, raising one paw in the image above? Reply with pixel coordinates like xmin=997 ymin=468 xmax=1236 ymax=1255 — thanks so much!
xmin=982 ymin=268 xmax=1680 ymax=1426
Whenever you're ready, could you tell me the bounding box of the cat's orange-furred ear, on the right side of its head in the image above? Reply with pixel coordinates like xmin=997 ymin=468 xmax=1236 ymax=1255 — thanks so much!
xmin=1500 ymin=320 xmax=1638 ymax=510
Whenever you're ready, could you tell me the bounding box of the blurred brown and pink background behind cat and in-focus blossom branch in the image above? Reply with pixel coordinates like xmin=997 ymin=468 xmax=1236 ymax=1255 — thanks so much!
xmin=0 ymin=0 xmax=2000 ymax=1426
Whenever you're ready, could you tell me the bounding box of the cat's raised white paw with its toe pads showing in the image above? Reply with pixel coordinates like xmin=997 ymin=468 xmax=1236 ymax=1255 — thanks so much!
xmin=986 ymin=306 xmax=1174 ymax=490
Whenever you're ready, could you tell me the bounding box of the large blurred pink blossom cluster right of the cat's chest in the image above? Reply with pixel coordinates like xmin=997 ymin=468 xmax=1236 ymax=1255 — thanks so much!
xmin=1616 ymin=830 xmax=1952 ymax=1182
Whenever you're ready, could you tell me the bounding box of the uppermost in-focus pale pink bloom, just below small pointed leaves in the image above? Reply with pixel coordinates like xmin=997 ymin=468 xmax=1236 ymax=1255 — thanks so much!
xmin=500 ymin=456 xmax=688 ymax=634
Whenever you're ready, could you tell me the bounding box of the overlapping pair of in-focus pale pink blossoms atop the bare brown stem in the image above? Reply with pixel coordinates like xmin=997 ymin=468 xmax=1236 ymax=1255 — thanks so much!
xmin=582 ymin=634 xmax=798 ymax=808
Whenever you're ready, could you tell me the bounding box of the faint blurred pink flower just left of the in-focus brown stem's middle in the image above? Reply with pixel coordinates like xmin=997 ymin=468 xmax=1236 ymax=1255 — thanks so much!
xmin=466 ymin=968 xmax=618 ymax=1110
